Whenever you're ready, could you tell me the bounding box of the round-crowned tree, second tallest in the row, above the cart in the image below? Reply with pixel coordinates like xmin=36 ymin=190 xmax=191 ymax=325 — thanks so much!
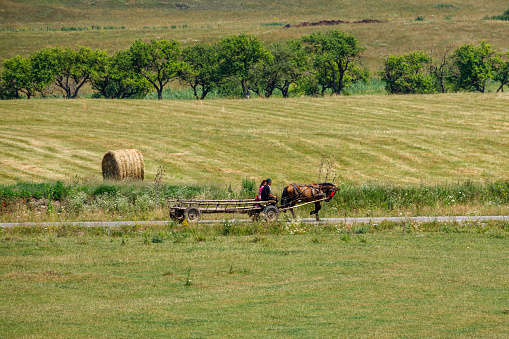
xmin=218 ymin=34 xmax=271 ymax=98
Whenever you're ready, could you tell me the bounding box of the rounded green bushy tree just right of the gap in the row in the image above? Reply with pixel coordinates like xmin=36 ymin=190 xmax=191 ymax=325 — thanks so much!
xmin=381 ymin=51 xmax=435 ymax=94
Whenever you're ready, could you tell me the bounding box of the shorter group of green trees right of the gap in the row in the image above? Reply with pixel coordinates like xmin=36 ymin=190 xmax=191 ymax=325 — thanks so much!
xmin=380 ymin=41 xmax=509 ymax=94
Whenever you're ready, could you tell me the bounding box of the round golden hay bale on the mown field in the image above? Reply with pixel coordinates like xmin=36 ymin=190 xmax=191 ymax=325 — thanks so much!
xmin=102 ymin=149 xmax=145 ymax=180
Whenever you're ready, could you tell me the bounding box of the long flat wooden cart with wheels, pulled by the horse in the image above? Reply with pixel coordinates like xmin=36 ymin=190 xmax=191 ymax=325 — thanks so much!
xmin=169 ymin=199 xmax=279 ymax=223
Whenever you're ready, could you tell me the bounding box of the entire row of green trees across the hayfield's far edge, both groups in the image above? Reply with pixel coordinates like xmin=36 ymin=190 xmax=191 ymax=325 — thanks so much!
xmin=0 ymin=30 xmax=509 ymax=99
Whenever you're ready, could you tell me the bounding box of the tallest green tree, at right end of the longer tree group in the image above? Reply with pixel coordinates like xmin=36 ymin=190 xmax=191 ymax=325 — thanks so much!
xmin=302 ymin=30 xmax=366 ymax=94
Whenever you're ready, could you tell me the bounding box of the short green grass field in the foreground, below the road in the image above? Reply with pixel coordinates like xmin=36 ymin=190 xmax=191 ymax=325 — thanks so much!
xmin=0 ymin=224 xmax=509 ymax=338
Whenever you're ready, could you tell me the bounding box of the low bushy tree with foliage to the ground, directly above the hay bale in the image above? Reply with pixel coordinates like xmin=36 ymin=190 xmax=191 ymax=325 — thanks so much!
xmin=91 ymin=51 xmax=152 ymax=99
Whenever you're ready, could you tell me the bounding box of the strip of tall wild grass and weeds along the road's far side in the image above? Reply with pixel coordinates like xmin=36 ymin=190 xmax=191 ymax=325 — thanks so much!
xmin=0 ymin=180 xmax=509 ymax=222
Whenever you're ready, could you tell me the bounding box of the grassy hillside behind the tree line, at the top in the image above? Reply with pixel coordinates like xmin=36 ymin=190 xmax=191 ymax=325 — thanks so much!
xmin=0 ymin=0 xmax=509 ymax=70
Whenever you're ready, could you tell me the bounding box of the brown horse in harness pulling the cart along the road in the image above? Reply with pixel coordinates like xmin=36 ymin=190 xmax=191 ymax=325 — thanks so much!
xmin=281 ymin=182 xmax=339 ymax=220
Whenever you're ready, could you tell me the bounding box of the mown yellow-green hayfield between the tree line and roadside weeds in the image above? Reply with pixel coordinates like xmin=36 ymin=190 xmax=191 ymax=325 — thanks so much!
xmin=0 ymin=94 xmax=509 ymax=185
